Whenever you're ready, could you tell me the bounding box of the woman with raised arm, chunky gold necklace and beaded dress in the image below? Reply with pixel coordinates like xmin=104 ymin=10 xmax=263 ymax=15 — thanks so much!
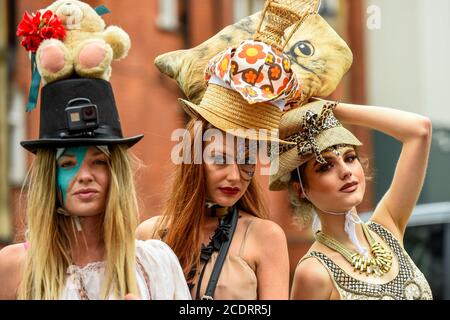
xmin=270 ymin=100 xmax=432 ymax=300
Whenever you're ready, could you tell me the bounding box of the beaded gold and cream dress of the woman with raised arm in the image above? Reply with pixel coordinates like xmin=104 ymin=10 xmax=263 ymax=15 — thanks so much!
xmin=301 ymin=222 xmax=433 ymax=300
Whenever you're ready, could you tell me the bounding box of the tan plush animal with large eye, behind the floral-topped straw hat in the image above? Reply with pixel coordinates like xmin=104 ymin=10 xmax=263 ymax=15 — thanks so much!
xmin=155 ymin=0 xmax=353 ymax=109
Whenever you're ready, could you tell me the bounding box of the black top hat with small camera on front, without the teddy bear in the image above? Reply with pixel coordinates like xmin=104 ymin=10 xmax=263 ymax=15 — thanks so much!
xmin=20 ymin=78 xmax=144 ymax=153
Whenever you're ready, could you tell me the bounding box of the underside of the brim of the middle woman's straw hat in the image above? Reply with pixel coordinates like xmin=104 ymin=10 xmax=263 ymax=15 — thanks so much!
xmin=178 ymin=99 xmax=294 ymax=145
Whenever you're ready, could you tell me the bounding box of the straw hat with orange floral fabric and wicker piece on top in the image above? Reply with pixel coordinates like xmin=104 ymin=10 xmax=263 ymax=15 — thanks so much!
xmin=179 ymin=0 xmax=317 ymax=144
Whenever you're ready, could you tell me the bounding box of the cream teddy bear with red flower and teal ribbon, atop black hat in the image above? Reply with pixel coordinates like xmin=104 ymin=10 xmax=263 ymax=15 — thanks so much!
xmin=17 ymin=0 xmax=131 ymax=111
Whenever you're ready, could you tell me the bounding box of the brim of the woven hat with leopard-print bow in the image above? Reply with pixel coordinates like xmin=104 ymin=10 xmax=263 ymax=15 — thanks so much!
xmin=269 ymin=127 xmax=362 ymax=191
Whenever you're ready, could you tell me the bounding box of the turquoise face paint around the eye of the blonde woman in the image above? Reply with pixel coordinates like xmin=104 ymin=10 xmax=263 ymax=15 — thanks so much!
xmin=56 ymin=147 xmax=89 ymax=205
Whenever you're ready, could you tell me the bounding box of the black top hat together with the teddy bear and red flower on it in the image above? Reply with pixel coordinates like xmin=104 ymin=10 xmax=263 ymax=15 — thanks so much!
xmin=17 ymin=0 xmax=143 ymax=153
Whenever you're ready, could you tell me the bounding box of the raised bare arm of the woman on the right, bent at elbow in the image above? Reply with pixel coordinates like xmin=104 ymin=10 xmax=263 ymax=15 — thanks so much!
xmin=334 ymin=103 xmax=432 ymax=241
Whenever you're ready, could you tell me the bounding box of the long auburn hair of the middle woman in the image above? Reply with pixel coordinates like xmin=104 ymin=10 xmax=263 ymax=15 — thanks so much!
xmin=154 ymin=118 xmax=268 ymax=278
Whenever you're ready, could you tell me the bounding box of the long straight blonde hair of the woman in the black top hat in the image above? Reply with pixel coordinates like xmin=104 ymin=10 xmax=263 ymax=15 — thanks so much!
xmin=18 ymin=145 xmax=138 ymax=300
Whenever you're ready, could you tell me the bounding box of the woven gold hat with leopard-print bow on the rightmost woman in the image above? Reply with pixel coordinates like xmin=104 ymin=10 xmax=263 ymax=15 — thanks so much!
xmin=269 ymin=100 xmax=362 ymax=191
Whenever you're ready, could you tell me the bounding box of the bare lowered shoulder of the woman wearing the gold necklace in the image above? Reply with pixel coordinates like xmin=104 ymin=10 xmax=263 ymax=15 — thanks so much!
xmin=291 ymin=258 xmax=333 ymax=300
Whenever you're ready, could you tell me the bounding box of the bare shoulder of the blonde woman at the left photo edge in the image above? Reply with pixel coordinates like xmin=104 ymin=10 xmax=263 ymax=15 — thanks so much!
xmin=0 ymin=244 xmax=26 ymax=299
